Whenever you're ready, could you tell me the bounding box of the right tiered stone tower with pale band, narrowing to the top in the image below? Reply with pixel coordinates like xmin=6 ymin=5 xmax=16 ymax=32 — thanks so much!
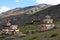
xmin=41 ymin=15 xmax=55 ymax=31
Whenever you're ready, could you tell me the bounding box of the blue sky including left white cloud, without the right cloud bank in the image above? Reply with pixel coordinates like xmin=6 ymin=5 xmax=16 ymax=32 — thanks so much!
xmin=0 ymin=0 xmax=37 ymax=13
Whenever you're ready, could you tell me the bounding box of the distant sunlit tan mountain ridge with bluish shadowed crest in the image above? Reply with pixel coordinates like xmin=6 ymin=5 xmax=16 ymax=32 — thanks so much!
xmin=0 ymin=4 xmax=51 ymax=17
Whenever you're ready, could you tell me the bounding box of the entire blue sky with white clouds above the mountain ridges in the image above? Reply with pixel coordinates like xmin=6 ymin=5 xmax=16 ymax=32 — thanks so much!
xmin=0 ymin=0 xmax=60 ymax=13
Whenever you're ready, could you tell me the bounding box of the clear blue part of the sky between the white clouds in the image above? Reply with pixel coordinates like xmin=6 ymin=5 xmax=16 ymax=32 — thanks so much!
xmin=0 ymin=0 xmax=37 ymax=8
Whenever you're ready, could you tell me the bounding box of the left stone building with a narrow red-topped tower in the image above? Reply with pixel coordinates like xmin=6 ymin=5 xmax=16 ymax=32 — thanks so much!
xmin=2 ymin=19 xmax=19 ymax=35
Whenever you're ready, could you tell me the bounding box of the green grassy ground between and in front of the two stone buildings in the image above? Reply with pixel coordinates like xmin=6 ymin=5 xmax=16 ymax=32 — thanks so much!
xmin=0 ymin=24 xmax=60 ymax=40
